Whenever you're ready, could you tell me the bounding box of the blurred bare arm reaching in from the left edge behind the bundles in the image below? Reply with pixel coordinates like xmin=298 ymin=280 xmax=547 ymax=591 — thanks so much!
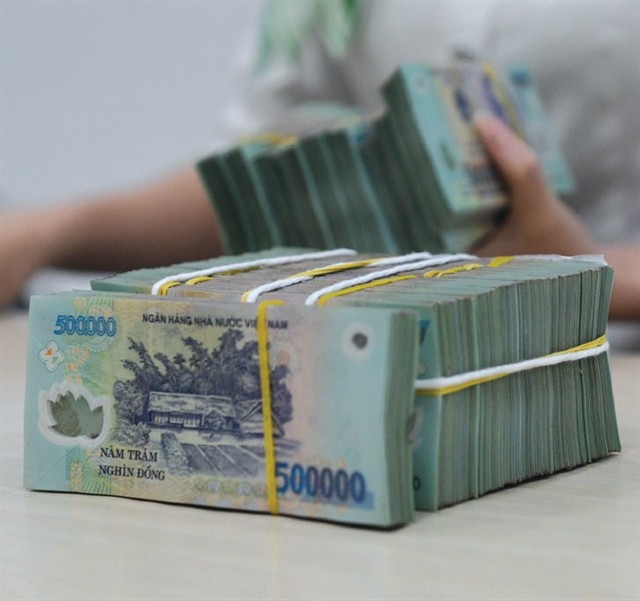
xmin=0 ymin=166 xmax=222 ymax=305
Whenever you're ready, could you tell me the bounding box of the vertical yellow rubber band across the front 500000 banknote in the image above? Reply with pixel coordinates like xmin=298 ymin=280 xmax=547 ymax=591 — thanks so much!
xmin=256 ymin=300 xmax=284 ymax=514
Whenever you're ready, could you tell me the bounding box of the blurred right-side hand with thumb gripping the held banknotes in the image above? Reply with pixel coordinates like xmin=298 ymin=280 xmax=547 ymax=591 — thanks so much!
xmin=475 ymin=116 xmax=600 ymax=256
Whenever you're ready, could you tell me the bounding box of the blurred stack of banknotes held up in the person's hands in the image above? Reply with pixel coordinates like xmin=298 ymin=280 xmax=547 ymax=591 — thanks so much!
xmin=198 ymin=61 xmax=573 ymax=254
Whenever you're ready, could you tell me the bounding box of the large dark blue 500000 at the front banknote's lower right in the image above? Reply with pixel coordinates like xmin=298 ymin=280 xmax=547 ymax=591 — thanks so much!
xmin=276 ymin=461 xmax=367 ymax=503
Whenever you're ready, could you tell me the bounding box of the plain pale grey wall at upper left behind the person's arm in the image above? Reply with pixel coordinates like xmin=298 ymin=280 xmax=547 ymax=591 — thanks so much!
xmin=0 ymin=0 xmax=262 ymax=210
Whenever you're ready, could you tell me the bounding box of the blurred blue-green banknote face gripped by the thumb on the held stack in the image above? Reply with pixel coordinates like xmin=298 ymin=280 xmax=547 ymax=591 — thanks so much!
xmin=383 ymin=61 xmax=572 ymax=225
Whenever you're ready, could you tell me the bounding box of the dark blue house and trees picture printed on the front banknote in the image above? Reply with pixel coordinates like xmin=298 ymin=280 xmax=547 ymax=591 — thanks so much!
xmin=113 ymin=329 xmax=292 ymax=476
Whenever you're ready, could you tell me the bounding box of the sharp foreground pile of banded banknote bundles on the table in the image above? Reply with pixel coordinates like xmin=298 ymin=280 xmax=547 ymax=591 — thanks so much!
xmin=25 ymin=248 xmax=620 ymax=527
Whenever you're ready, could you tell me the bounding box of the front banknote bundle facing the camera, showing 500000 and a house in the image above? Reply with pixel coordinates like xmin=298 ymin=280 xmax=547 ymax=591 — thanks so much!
xmin=24 ymin=292 xmax=417 ymax=527
